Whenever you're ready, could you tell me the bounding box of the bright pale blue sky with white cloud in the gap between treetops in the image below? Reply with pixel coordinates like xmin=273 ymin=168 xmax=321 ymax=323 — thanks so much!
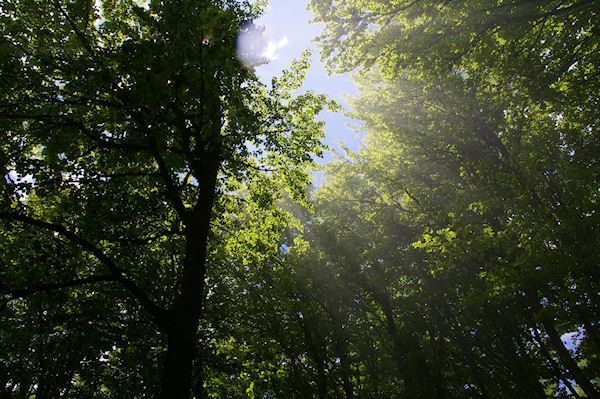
xmin=243 ymin=0 xmax=360 ymax=163
